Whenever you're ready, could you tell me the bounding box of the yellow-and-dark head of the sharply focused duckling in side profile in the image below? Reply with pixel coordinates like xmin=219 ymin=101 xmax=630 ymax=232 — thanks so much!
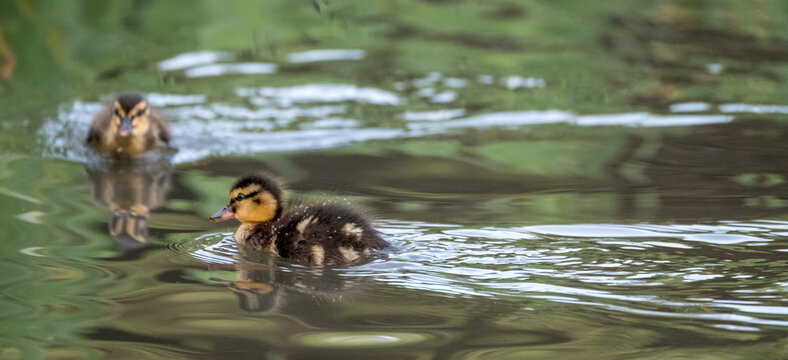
xmin=211 ymin=173 xmax=282 ymax=223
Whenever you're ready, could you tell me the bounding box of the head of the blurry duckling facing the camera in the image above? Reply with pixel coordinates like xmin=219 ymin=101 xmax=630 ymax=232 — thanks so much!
xmin=110 ymin=93 xmax=150 ymax=138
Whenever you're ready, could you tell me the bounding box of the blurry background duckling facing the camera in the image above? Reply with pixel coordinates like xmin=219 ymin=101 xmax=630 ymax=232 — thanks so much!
xmin=86 ymin=93 xmax=170 ymax=157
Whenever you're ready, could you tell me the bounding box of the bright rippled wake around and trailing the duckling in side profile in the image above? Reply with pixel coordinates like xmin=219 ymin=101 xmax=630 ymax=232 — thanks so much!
xmin=194 ymin=221 xmax=788 ymax=331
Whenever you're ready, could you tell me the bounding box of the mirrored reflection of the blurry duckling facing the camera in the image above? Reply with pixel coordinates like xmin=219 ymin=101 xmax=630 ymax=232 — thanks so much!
xmin=86 ymin=162 xmax=172 ymax=250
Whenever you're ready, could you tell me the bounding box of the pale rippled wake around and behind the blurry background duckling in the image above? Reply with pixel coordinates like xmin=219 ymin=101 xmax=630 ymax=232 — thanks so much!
xmin=38 ymin=82 xmax=744 ymax=165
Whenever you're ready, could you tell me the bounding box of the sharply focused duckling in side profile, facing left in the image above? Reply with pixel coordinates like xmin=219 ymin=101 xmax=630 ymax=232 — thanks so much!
xmin=210 ymin=173 xmax=388 ymax=265
